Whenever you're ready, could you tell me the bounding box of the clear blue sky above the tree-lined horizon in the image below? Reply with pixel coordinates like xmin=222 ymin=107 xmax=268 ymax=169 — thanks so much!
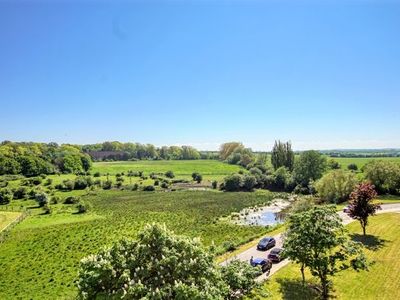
xmin=0 ymin=0 xmax=400 ymax=150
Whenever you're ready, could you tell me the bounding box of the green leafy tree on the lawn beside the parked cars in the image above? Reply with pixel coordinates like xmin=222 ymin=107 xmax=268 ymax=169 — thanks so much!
xmin=284 ymin=206 xmax=366 ymax=299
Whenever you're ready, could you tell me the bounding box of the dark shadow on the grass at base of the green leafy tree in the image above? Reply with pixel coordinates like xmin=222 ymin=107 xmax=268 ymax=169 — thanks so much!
xmin=277 ymin=278 xmax=320 ymax=300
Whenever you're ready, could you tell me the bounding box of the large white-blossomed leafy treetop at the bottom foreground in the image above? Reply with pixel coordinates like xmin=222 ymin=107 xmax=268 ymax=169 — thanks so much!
xmin=78 ymin=225 xmax=228 ymax=299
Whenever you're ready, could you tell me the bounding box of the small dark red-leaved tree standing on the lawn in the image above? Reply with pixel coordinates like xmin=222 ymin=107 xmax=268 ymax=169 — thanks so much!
xmin=348 ymin=183 xmax=381 ymax=236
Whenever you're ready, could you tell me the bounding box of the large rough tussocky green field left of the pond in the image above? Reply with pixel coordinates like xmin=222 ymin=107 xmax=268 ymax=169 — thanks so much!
xmin=0 ymin=190 xmax=274 ymax=299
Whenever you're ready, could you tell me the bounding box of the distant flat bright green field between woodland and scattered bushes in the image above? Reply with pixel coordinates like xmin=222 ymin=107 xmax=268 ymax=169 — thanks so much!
xmin=91 ymin=160 xmax=242 ymax=181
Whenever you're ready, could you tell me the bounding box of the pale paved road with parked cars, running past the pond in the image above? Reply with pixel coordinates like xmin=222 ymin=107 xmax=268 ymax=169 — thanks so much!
xmin=222 ymin=203 xmax=400 ymax=281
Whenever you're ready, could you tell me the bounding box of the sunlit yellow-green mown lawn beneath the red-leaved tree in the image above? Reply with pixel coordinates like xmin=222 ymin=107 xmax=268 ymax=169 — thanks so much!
xmin=249 ymin=213 xmax=400 ymax=300
